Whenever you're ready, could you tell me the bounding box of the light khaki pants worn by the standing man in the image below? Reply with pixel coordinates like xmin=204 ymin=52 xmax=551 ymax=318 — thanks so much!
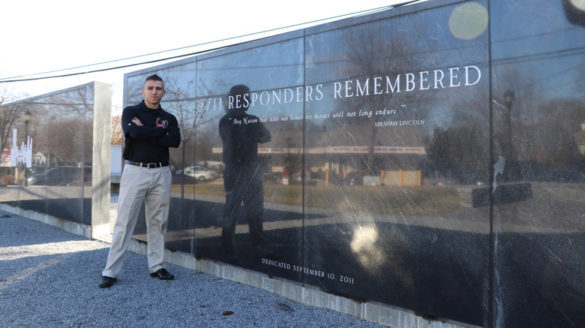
xmin=102 ymin=165 xmax=171 ymax=278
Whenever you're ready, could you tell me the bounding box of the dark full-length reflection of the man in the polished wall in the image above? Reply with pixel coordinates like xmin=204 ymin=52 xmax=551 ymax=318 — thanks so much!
xmin=219 ymin=85 xmax=270 ymax=260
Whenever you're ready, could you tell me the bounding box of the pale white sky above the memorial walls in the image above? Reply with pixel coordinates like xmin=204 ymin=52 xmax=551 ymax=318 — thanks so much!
xmin=0 ymin=0 xmax=416 ymax=113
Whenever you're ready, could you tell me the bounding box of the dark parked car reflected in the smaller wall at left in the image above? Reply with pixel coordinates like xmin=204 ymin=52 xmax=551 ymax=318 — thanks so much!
xmin=26 ymin=167 xmax=91 ymax=186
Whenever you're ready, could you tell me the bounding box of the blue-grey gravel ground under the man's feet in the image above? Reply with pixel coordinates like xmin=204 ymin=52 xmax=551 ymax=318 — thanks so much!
xmin=0 ymin=211 xmax=381 ymax=328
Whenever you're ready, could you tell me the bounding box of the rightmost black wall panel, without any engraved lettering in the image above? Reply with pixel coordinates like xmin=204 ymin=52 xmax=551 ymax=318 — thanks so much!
xmin=492 ymin=1 xmax=585 ymax=327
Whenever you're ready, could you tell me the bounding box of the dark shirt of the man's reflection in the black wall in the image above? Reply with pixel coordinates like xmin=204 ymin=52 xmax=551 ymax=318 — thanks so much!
xmin=219 ymin=110 xmax=271 ymax=164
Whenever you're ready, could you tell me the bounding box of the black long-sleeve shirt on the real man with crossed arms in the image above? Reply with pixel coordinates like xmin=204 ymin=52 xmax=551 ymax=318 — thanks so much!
xmin=122 ymin=101 xmax=181 ymax=163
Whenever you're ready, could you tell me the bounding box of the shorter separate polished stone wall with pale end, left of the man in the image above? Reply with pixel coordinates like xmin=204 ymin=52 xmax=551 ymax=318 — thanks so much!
xmin=0 ymin=82 xmax=111 ymax=226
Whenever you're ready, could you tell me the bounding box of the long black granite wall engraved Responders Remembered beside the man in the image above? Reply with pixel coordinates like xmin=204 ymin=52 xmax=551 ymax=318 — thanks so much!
xmin=125 ymin=0 xmax=585 ymax=328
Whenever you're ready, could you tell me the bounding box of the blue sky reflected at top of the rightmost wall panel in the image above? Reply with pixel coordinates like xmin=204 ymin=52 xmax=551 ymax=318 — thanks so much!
xmin=492 ymin=0 xmax=585 ymax=98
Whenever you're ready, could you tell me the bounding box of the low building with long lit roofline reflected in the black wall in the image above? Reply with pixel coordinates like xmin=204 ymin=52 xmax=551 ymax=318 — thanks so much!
xmin=212 ymin=124 xmax=426 ymax=186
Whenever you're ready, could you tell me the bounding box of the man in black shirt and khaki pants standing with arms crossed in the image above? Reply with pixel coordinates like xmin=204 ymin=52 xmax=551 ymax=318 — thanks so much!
xmin=99 ymin=74 xmax=181 ymax=288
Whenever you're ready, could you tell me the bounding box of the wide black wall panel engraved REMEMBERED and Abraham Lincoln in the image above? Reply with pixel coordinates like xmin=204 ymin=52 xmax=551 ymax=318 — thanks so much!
xmin=303 ymin=3 xmax=490 ymax=325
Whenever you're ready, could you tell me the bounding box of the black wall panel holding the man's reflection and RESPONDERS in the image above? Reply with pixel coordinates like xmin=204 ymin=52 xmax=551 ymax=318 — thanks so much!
xmin=195 ymin=38 xmax=303 ymax=280
